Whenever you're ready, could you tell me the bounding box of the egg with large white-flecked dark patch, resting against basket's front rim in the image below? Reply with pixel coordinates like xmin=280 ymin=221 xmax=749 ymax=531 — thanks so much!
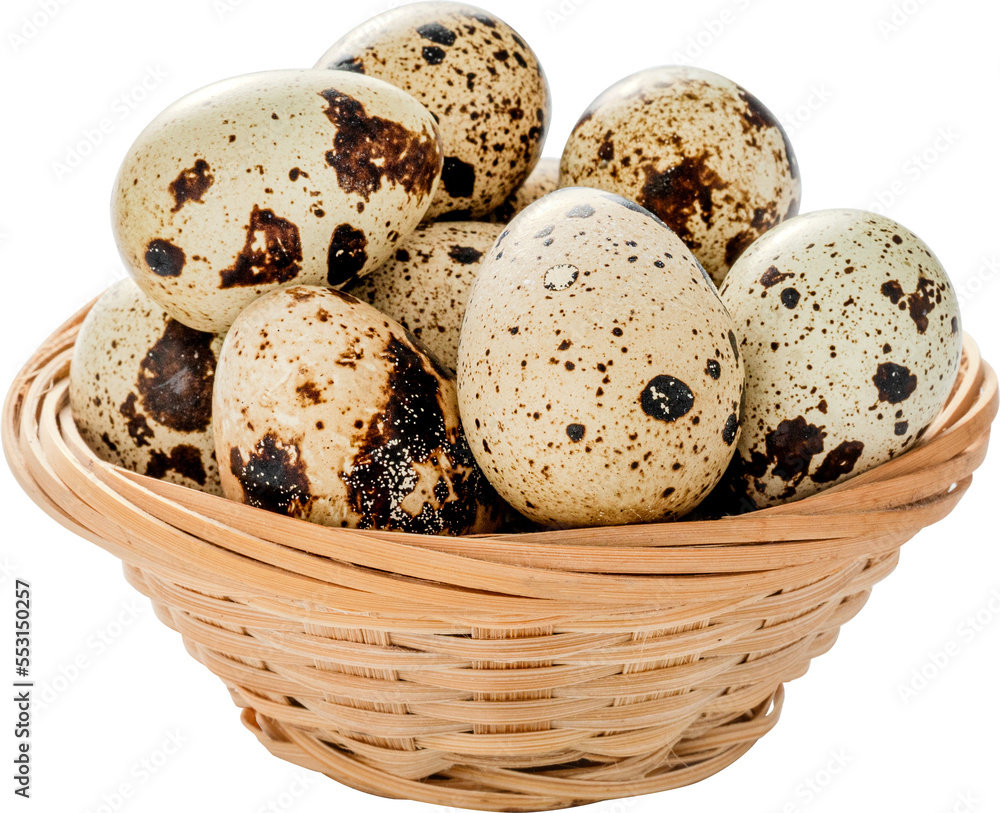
xmin=214 ymin=286 xmax=502 ymax=534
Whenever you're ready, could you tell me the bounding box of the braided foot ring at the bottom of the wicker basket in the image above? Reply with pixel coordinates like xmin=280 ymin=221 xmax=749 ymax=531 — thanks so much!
xmin=240 ymin=686 xmax=784 ymax=813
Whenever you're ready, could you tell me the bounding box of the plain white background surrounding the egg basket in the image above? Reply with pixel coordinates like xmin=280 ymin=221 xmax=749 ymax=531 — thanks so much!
xmin=0 ymin=0 xmax=1000 ymax=813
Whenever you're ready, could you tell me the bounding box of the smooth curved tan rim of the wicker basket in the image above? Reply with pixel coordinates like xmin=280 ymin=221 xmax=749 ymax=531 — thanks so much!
xmin=3 ymin=300 xmax=1000 ymax=609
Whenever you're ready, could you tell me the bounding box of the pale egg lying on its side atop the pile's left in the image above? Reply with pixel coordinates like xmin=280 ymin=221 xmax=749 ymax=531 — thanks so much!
xmin=112 ymin=70 xmax=442 ymax=333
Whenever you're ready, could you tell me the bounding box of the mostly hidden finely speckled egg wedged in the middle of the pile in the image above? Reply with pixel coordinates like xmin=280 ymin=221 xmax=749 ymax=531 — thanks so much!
xmin=347 ymin=221 xmax=503 ymax=370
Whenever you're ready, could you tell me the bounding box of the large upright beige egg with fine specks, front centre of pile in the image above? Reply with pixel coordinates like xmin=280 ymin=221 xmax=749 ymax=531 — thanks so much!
xmin=458 ymin=188 xmax=743 ymax=527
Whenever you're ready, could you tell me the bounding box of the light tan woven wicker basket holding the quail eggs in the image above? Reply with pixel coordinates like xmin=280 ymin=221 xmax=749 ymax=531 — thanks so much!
xmin=3 ymin=308 xmax=998 ymax=811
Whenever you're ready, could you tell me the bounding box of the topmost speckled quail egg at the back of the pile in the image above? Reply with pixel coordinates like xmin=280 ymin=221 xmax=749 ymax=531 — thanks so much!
xmin=316 ymin=2 xmax=551 ymax=218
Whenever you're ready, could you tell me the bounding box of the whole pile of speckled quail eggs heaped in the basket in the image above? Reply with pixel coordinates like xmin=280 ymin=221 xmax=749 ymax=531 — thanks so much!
xmin=70 ymin=2 xmax=962 ymax=535
